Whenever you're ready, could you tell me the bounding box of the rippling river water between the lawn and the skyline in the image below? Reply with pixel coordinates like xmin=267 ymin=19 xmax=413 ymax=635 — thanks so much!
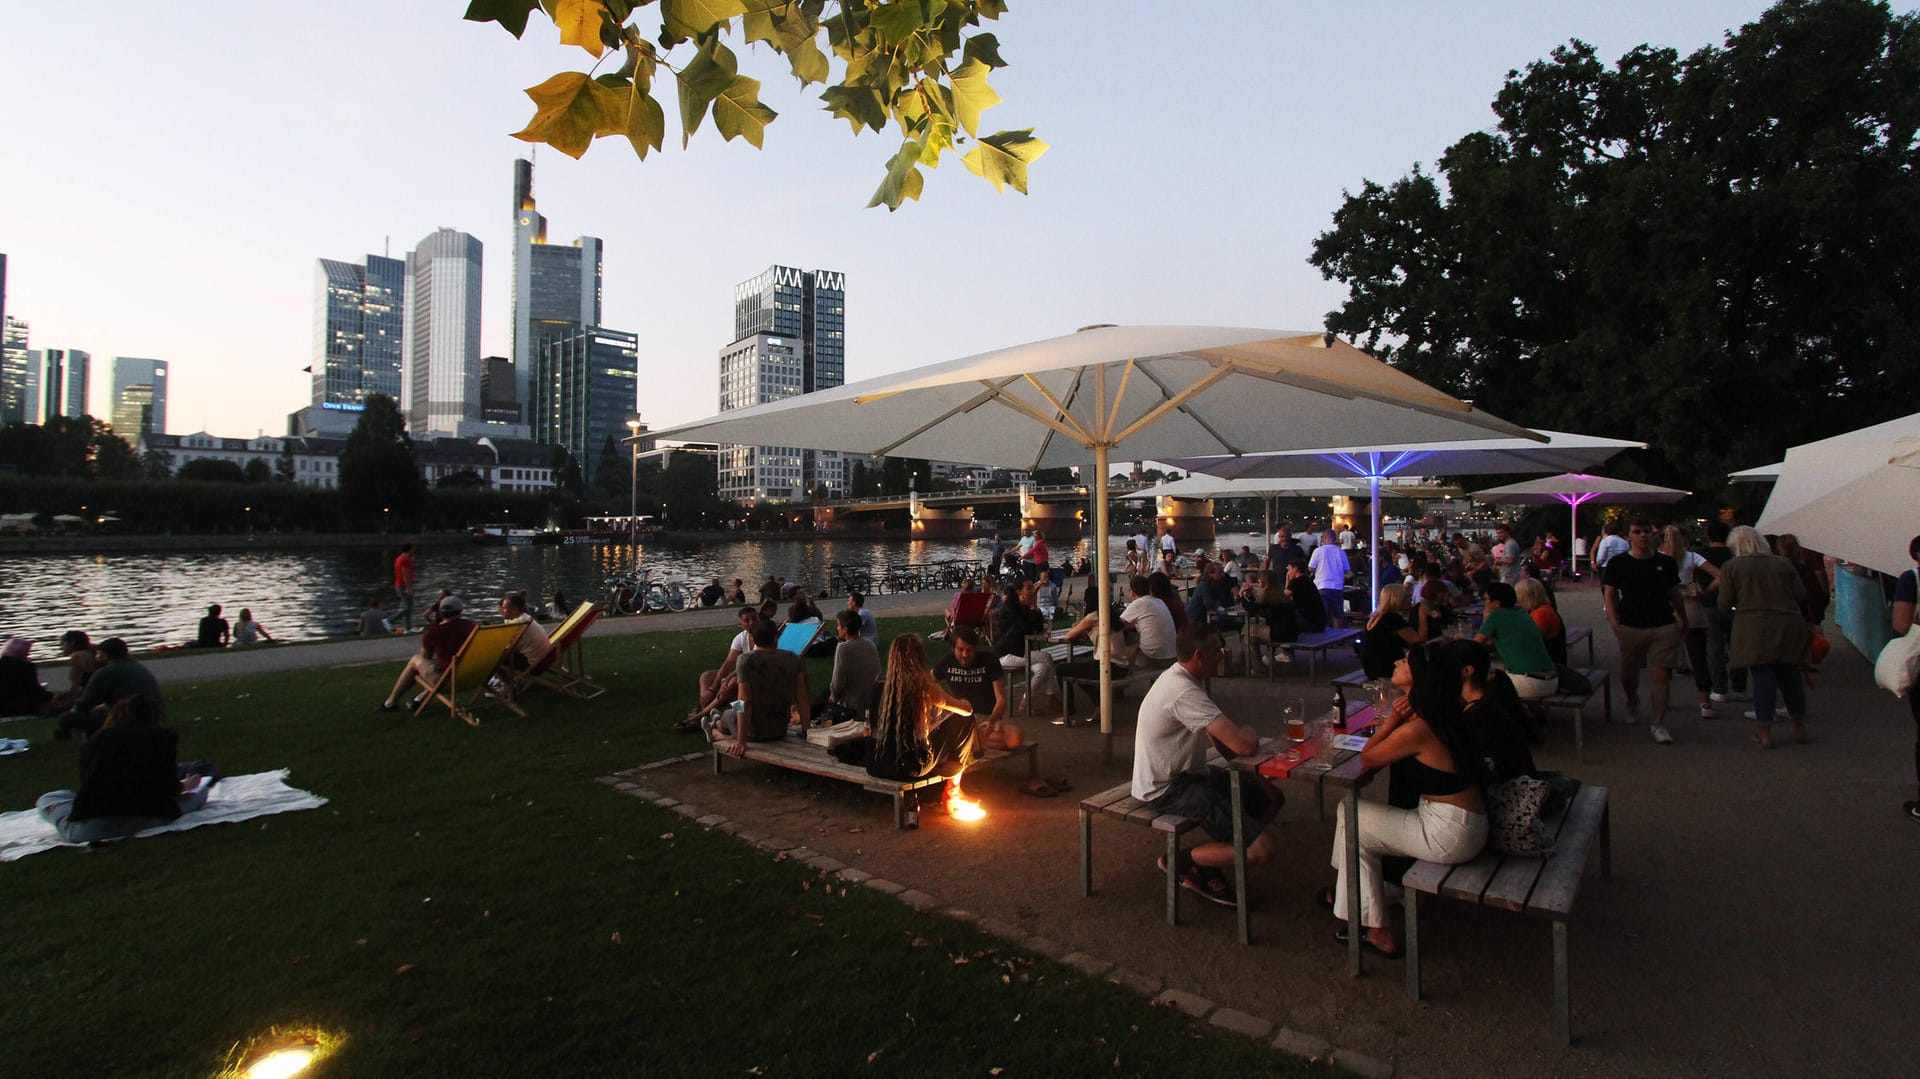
xmin=0 ymin=534 xmax=1260 ymax=645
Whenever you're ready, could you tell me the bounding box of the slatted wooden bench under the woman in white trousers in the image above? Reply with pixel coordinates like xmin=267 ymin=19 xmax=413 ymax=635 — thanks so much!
xmin=1400 ymin=787 xmax=1613 ymax=1044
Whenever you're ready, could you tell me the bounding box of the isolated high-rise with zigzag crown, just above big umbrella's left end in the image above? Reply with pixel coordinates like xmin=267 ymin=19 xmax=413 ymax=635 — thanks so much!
xmin=720 ymin=267 xmax=847 ymax=501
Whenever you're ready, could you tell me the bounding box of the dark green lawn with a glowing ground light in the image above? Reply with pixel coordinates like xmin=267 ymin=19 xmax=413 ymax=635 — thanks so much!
xmin=0 ymin=620 xmax=1313 ymax=1077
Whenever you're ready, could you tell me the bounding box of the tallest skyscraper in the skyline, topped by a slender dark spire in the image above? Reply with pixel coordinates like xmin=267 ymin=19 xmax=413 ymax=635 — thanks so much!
xmin=511 ymin=159 xmax=601 ymax=405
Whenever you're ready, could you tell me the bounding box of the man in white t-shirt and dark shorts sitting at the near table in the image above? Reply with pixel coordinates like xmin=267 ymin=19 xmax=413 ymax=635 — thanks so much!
xmin=1133 ymin=622 xmax=1284 ymax=906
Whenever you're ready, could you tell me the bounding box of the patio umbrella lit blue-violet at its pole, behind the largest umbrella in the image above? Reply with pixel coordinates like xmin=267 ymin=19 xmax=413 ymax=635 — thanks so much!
xmin=1160 ymin=430 xmax=1647 ymax=603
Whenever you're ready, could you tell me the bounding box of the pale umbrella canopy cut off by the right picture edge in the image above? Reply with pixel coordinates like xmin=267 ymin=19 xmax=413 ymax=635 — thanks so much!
xmin=1759 ymin=417 xmax=1920 ymax=574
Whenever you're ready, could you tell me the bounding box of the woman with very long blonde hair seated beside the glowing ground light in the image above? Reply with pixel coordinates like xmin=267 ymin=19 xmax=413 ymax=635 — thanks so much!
xmin=866 ymin=634 xmax=973 ymax=779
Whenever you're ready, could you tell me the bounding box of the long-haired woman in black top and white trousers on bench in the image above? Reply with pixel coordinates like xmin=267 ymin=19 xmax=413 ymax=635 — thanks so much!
xmin=1321 ymin=643 xmax=1488 ymax=958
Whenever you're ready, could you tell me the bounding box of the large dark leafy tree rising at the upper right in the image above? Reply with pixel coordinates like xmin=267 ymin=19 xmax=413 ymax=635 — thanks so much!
xmin=1311 ymin=0 xmax=1920 ymax=492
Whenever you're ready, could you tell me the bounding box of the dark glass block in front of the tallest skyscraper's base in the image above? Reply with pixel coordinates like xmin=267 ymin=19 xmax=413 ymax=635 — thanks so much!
xmin=528 ymin=326 xmax=639 ymax=484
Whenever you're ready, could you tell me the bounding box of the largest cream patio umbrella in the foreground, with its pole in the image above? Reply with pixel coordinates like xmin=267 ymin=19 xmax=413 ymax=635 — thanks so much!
xmin=653 ymin=326 xmax=1532 ymax=755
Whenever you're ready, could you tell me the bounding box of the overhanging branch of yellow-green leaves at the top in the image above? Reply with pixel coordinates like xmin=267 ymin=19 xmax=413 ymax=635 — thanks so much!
xmin=467 ymin=0 xmax=1046 ymax=209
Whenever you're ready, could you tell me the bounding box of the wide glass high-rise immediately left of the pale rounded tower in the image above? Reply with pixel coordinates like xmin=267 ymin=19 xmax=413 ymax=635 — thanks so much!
xmin=311 ymin=255 xmax=407 ymax=413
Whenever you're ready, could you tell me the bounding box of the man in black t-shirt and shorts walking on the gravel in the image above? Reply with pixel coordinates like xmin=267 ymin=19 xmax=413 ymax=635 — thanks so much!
xmin=1599 ymin=516 xmax=1686 ymax=745
